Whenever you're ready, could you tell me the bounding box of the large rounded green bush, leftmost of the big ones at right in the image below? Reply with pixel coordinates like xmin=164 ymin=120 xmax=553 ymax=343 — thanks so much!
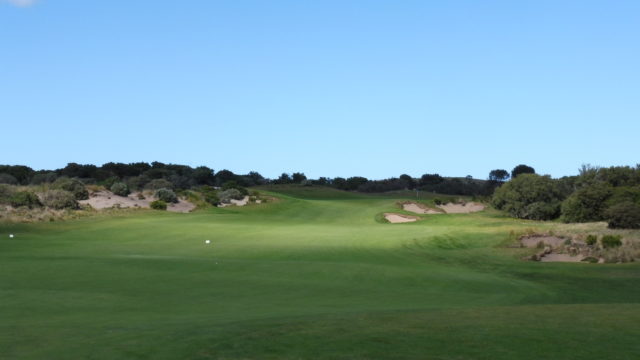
xmin=491 ymin=174 xmax=562 ymax=220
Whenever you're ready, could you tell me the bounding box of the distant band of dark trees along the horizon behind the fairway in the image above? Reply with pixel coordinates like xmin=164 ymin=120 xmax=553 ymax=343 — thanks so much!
xmin=0 ymin=162 xmax=520 ymax=196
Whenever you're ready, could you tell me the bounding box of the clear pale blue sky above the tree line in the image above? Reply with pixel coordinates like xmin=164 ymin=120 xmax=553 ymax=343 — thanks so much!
xmin=0 ymin=0 xmax=640 ymax=178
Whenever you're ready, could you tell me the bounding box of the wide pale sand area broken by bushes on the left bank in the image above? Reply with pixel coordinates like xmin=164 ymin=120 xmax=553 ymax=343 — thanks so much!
xmin=78 ymin=191 xmax=196 ymax=213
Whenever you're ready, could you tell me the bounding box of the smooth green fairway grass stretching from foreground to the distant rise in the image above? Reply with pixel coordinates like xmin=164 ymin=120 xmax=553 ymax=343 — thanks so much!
xmin=0 ymin=186 xmax=640 ymax=360
